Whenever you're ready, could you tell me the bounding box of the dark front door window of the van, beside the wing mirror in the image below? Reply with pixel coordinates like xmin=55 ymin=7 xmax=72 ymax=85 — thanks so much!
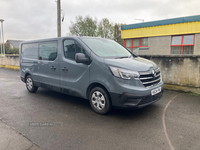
xmin=64 ymin=40 xmax=85 ymax=60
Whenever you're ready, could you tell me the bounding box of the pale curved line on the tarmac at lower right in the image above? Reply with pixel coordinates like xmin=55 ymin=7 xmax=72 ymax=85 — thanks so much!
xmin=163 ymin=94 xmax=179 ymax=150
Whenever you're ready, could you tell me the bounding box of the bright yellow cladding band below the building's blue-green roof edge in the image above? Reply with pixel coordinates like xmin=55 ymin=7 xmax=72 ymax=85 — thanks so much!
xmin=121 ymin=21 xmax=200 ymax=39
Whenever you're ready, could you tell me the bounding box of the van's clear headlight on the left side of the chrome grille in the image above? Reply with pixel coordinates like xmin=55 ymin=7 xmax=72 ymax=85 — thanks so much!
xmin=110 ymin=66 xmax=140 ymax=80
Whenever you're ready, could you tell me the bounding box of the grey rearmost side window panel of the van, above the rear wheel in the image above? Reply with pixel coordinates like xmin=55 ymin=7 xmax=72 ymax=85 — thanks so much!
xmin=21 ymin=43 xmax=38 ymax=59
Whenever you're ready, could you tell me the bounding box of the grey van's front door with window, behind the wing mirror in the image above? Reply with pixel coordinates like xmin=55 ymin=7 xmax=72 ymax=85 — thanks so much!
xmin=60 ymin=39 xmax=89 ymax=98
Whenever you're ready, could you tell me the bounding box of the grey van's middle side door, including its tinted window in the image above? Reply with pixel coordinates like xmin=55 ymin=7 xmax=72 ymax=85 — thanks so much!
xmin=38 ymin=41 xmax=60 ymax=90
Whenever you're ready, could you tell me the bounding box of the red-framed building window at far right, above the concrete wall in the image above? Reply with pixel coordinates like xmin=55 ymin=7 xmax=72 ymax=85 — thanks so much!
xmin=171 ymin=35 xmax=194 ymax=54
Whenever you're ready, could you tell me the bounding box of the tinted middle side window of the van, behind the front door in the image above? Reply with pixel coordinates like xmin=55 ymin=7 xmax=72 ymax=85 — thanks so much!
xmin=39 ymin=41 xmax=58 ymax=61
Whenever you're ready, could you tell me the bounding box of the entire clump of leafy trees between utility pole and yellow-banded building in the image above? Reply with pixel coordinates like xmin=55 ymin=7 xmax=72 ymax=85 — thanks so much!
xmin=69 ymin=16 xmax=125 ymax=44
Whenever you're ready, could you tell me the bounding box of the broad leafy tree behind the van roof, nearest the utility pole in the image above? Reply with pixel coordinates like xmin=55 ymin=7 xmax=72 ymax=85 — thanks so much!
xmin=69 ymin=16 xmax=97 ymax=36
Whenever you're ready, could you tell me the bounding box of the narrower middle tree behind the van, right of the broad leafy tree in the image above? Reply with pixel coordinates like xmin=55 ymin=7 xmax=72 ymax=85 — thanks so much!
xmin=97 ymin=18 xmax=114 ymax=39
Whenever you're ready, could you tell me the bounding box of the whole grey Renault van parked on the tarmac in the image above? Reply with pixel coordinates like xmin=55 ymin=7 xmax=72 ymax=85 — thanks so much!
xmin=19 ymin=37 xmax=163 ymax=114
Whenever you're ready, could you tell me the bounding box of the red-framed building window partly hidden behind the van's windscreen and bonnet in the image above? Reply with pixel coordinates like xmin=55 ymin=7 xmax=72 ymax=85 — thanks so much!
xmin=124 ymin=38 xmax=148 ymax=54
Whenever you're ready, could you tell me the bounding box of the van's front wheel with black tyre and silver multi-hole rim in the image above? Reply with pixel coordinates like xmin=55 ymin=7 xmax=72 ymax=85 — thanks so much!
xmin=89 ymin=87 xmax=112 ymax=115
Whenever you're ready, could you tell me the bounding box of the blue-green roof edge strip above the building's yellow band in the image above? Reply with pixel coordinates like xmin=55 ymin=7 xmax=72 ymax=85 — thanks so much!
xmin=121 ymin=15 xmax=200 ymax=30
